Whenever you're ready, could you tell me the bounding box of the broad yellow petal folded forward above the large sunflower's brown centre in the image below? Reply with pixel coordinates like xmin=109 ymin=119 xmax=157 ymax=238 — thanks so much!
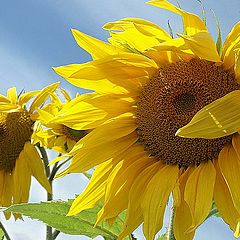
xmin=179 ymin=31 xmax=221 ymax=62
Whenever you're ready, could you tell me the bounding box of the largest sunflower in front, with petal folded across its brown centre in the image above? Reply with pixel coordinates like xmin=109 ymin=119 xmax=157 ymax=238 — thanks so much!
xmin=52 ymin=0 xmax=240 ymax=240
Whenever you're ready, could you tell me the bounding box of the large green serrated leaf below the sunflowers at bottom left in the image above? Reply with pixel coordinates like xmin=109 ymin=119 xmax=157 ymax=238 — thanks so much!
xmin=5 ymin=200 xmax=130 ymax=240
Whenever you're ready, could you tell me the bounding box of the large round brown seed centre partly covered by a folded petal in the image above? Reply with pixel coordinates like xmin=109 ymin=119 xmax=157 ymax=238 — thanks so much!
xmin=136 ymin=59 xmax=239 ymax=167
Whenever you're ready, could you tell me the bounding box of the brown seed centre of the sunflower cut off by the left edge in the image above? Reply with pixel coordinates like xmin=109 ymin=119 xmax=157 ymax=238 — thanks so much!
xmin=0 ymin=111 xmax=34 ymax=172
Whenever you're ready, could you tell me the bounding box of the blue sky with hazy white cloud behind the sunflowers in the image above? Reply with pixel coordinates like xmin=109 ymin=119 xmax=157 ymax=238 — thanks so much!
xmin=0 ymin=0 xmax=240 ymax=240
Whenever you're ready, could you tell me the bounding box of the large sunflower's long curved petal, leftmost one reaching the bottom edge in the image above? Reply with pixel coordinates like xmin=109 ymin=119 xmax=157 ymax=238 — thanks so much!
xmin=119 ymin=161 xmax=163 ymax=239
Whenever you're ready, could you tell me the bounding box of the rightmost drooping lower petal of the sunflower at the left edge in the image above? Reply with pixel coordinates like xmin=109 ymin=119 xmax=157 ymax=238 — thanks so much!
xmin=23 ymin=142 xmax=52 ymax=193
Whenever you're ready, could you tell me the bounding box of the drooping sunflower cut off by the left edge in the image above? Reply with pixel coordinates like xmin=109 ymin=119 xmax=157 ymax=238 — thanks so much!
xmin=0 ymin=83 xmax=58 ymax=218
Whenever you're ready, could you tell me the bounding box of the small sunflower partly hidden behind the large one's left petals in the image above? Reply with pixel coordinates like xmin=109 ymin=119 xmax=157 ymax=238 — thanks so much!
xmin=33 ymin=89 xmax=86 ymax=153
